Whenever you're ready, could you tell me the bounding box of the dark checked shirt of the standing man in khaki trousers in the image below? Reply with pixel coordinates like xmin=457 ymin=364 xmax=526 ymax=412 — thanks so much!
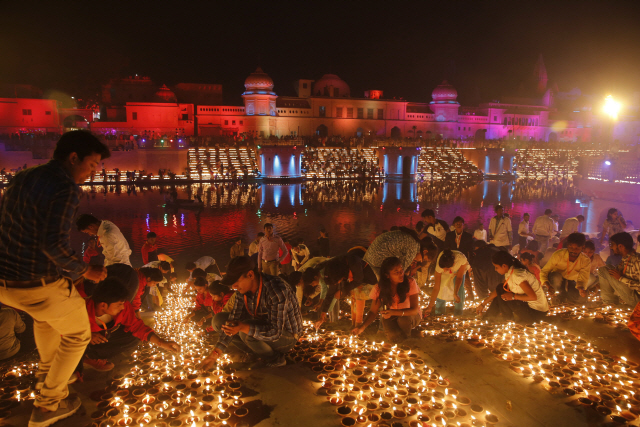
xmin=0 ymin=160 xmax=87 ymax=280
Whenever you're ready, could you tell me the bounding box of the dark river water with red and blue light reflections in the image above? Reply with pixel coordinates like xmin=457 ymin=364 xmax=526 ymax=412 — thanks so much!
xmin=66 ymin=180 xmax=586 ymax=272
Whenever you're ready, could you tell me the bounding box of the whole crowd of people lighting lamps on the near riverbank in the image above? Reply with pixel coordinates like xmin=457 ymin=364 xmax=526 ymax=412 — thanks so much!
xmin=0 ymin=131 xmax=640 ymax=427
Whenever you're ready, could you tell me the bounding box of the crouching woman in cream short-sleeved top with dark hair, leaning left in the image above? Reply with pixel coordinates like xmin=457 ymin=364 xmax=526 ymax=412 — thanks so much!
xmin=476 ymin=251 xmax=549 ymax=324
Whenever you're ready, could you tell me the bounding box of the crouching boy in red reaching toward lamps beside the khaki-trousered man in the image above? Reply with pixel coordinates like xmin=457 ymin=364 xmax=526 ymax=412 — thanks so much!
xmin=82 ymin=279 xmax=180 ymax=371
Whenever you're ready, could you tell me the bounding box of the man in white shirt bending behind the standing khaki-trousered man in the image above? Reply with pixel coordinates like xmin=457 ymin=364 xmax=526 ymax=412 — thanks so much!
xmin=76 ymin=214 xmax=131 ymax=267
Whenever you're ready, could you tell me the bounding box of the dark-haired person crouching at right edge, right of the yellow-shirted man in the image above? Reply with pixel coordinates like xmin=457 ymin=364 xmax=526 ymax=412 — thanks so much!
xmin=598 ymin=232 xmax=640 ymax=307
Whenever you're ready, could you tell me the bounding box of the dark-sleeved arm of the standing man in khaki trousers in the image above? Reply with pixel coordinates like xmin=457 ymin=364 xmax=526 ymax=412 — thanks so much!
xmin=42 ymin=188 xmax=87 ymax=274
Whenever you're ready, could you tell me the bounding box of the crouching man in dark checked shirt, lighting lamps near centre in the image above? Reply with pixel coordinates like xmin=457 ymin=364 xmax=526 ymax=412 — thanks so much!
xmin=202 ymin=256 xmax=303 ymax=369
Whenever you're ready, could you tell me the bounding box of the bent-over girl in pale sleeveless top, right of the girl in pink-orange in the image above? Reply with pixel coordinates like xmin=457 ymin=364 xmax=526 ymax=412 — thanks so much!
xmin=425 ymin=249 xmax=469 ymax=316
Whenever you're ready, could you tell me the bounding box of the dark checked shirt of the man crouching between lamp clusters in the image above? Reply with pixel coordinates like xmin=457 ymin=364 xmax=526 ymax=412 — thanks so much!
xmin=216 ymin=274 xmax=302 ymax=352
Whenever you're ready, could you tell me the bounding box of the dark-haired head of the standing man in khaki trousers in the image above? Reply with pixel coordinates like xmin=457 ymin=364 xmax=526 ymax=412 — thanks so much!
xmin=53 ymin=130 xmax=111 ymax=184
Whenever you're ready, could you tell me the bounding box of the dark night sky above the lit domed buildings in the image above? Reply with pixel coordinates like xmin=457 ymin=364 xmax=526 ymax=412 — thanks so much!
xmin=0 ymin=0 xmax=640 ymax=105
